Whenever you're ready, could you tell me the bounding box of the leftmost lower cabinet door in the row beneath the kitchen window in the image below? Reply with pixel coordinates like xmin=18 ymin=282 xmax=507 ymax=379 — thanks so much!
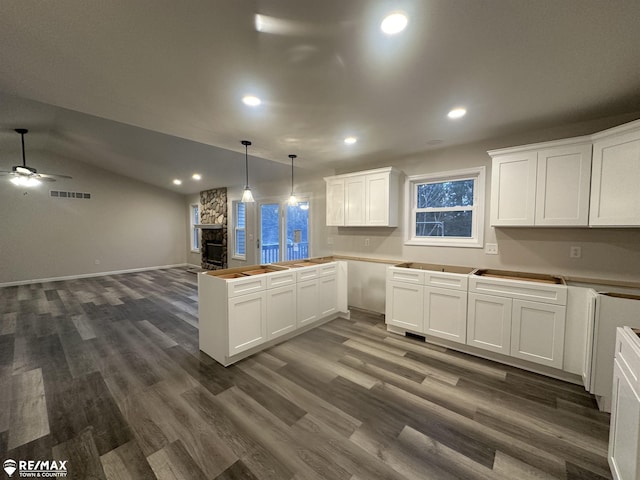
xmin=385 ymin=281 xmax=424 ymax=332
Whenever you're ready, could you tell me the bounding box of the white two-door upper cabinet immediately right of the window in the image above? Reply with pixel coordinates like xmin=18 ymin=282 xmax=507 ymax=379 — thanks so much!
xmin=488 ymin=137 xmax=591 ymax=227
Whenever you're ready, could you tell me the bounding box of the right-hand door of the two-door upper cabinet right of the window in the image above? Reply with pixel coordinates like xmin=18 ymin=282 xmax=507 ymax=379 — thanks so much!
xmin=535 ymin=144 xmax=591 ymax=226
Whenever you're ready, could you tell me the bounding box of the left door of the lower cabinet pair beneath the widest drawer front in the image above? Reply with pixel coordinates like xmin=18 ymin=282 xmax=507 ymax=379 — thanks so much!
xmin=467 ymin=293 xmax=513 ymax=355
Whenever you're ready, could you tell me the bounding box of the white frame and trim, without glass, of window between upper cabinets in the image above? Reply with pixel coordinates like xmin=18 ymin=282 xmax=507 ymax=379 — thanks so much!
xmin=404 ymin=166 xmax=486 ymax=248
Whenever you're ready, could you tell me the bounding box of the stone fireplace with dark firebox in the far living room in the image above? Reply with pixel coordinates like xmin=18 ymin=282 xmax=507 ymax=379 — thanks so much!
xmin=200 ymin=188 xmax=227 ymax=270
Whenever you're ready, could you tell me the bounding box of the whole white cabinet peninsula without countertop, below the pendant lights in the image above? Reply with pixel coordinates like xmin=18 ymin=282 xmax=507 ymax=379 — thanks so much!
xmin=198 ymin=259 xmax=348 ymax=366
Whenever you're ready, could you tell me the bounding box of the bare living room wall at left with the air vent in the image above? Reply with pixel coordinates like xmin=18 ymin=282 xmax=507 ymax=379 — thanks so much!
xmin=0 ymin=152 xmax=188 ymax=284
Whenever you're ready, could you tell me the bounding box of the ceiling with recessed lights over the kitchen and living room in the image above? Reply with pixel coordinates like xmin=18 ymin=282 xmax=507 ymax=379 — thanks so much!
xmin=0 ymin=0 xmax=640 ymax=193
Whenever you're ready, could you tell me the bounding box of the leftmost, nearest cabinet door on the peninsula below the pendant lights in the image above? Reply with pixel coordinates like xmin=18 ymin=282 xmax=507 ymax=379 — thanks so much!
xmin=228 ymin=291 xmax=267 ymax=355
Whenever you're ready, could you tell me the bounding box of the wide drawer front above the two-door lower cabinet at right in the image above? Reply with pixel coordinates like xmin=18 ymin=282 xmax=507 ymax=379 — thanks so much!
xmin=469 ymin=275 xmax=567 ymax=305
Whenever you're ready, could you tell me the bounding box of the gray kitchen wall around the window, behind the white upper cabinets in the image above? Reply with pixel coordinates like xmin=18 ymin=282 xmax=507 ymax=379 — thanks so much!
xmin=324 ymin=116 xmax=640 ymax=282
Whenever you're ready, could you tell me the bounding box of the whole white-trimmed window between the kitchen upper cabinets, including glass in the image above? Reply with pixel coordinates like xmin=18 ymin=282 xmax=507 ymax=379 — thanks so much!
xmin=405 ymin=167 xmax=485 ymax=248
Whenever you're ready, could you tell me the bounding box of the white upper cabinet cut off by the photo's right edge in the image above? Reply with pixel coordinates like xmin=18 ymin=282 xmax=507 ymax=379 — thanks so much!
xmin=589 ymin=120 xmax=640 ymax=227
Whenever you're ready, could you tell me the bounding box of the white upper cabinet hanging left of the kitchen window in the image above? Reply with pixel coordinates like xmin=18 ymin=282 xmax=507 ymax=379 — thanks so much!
xmin=324 ymin=167 xmax=400 ymax=227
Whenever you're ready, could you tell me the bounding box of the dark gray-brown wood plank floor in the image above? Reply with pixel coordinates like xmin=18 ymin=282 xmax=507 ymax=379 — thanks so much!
xmin=0 ymin=269 xmax=611 ymax=480
